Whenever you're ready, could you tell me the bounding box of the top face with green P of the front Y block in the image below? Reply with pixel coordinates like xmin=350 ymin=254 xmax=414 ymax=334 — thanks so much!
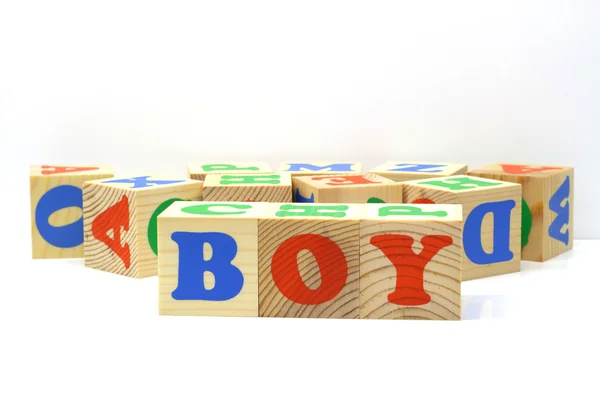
xmin=365 ymin=204 xmax=463 ymax=222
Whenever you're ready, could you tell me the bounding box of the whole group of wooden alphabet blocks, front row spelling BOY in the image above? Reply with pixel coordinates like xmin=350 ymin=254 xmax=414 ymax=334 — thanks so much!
xmin=30 ymin=161 xmax=574 ymax=320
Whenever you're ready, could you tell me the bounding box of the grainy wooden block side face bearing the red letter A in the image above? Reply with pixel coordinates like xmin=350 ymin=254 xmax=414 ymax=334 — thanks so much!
xmin=83 ymin=182 xmax=138 ymax=277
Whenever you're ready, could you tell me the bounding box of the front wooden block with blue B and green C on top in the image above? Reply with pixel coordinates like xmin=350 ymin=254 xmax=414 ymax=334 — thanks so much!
xmin=158 ymin=201 xmax=267 ymax=317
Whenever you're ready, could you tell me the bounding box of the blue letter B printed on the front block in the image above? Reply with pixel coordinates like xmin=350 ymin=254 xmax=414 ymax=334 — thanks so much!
xmin=171 ymin=232 xmax=244 ymax=301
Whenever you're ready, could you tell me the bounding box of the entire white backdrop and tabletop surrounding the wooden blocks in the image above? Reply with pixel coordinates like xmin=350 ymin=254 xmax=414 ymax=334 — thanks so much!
xmin=0 ymin=0 xmax=600 ymax=399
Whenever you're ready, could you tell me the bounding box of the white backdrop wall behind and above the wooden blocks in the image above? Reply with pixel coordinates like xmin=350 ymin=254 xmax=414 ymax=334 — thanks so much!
xmin=0 ymin=0 xmax=600 ymax=238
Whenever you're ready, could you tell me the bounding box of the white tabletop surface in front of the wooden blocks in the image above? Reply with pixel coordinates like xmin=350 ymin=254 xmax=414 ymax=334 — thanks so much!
xmin=0 ymin=241 xmax=600 ymax=400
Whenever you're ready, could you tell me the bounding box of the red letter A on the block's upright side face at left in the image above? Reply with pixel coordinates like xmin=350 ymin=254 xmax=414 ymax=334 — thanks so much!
xmin=92 ymin=195 xmax=131 ymax=268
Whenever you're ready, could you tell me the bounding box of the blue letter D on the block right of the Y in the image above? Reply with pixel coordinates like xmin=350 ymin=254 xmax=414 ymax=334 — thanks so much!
xmin=463 ymin=200 xmax=516 ymax=265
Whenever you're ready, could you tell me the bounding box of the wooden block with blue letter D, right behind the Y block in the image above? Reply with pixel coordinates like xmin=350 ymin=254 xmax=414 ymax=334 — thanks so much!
xmin=403 ymin=175 xmax=521 ymax=281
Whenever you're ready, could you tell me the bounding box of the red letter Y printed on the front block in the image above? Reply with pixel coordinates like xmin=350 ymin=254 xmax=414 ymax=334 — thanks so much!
xmin=371 ymin=234 xmax=452 ymax=306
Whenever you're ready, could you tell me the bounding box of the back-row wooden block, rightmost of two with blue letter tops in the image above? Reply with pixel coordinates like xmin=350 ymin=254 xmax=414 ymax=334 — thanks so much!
xmin=369 ymin=161 xmax=467 ymax=182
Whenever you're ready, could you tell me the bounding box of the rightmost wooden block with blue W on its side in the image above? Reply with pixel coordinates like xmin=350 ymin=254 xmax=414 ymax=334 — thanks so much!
xmin=468 ymin=164 xmax=575 ymax=261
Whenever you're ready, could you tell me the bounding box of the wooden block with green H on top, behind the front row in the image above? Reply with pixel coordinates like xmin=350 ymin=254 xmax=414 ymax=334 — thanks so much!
xmin=204 ymin=173 xmax=292 ymax=203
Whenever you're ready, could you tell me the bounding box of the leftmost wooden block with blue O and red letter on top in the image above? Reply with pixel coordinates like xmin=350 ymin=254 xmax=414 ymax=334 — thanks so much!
xmin=29 ymin=165 xmax=113 ymax=259
